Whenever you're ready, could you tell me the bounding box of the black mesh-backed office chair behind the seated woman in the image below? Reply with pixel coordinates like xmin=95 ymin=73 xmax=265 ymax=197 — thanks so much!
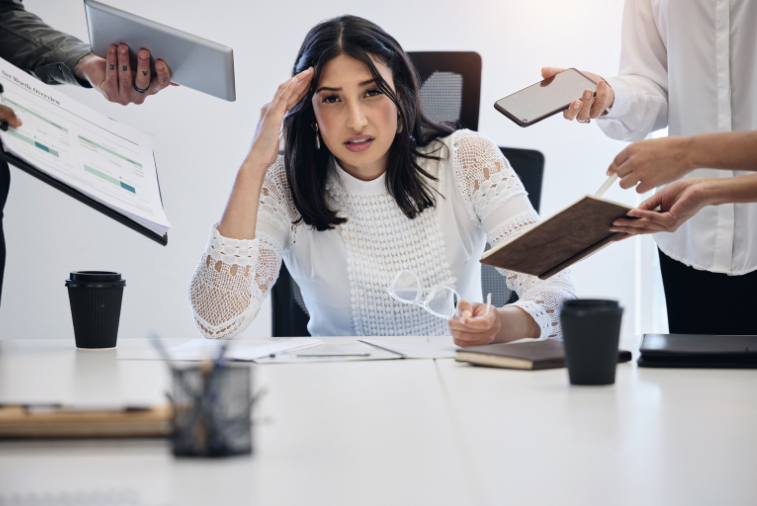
xmin=271 ymin=52 xmax=544 ymax=337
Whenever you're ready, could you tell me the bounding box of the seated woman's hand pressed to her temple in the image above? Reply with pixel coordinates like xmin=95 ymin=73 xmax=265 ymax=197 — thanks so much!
xmin=247 ymin=67 xmax=314 ymax=172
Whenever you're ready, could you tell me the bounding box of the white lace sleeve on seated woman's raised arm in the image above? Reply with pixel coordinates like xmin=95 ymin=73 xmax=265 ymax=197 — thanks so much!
xmin=189 ymin=160 xmax=291 ymax=339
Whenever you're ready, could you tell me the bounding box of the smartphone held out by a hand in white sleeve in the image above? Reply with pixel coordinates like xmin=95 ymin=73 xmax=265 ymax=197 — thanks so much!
xmin=494 ymin=69 xmax=597 ymax=127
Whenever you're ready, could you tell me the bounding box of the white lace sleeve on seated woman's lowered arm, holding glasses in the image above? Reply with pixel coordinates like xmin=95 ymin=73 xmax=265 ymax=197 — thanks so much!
xmin=453 ymin=131 xmax=576 ymax=338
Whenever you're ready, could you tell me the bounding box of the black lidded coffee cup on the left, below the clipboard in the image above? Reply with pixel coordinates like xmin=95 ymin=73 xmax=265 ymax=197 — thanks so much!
xmin=66 ymin=271 xmax=126 ymax=348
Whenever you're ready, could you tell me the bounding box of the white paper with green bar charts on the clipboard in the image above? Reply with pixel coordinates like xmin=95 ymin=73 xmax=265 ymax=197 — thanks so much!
xmin=0 ymin=60 xmax=170 ymax=234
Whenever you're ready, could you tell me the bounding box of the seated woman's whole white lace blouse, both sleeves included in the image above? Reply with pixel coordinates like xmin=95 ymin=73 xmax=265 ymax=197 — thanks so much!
xmin=189 ymin=130 xmax=575 ymax=339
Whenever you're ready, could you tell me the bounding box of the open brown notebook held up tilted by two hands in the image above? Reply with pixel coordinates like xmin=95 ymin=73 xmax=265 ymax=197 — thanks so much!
xmin=481 ymin=195 xmax=633 ymax=279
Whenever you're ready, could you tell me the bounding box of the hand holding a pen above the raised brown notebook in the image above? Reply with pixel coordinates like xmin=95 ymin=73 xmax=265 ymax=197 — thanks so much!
xmin=607 ymin=137 xmax=694 ymax=193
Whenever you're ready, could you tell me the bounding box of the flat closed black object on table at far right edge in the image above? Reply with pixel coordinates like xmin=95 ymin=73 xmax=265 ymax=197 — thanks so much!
xmin=639 ymin=334 xmax=757 ymax=369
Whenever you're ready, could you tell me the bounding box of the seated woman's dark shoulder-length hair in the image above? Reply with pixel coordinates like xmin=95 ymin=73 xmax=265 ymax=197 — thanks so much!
xmin=284 ymin=16 xmax=454 ymax=231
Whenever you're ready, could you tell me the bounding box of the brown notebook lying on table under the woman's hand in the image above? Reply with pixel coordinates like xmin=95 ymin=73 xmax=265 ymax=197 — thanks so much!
xmin=455 ymin=339 xmax=631 ymax=370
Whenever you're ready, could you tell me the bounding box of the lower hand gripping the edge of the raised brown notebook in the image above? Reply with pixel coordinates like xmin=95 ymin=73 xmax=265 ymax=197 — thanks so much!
xmin=610 ymin=177 xmax=716 ymax=237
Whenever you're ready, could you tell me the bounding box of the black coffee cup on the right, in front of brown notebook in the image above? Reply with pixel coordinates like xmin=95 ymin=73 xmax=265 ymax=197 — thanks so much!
xmin=560 ymin=299 xmax=623 ymax=385
